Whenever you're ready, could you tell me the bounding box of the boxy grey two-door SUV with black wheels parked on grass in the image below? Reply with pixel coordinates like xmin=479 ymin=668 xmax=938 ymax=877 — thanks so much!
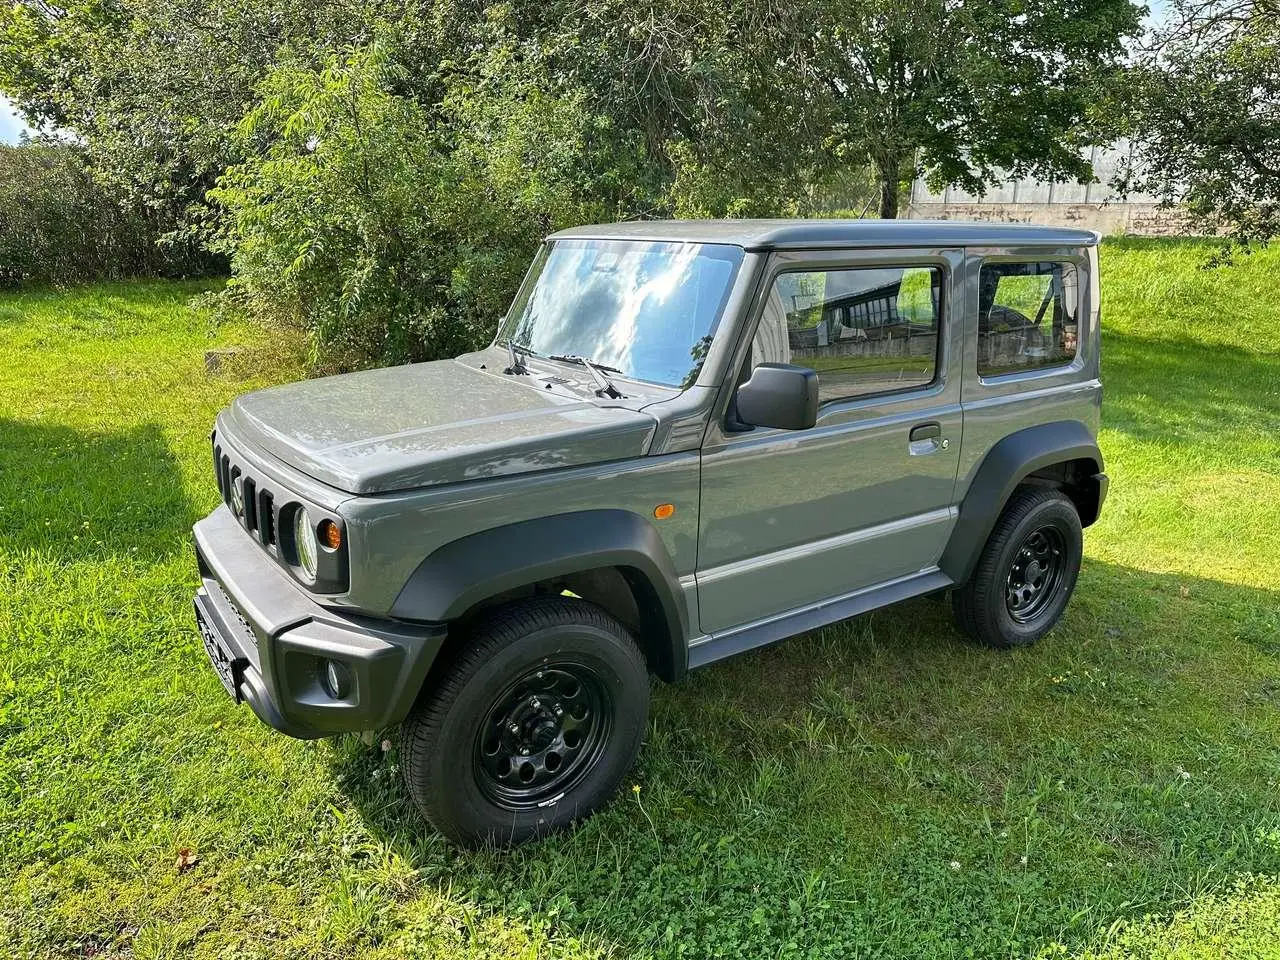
xmin=195 ymin=220 xmax=1107 ymax=844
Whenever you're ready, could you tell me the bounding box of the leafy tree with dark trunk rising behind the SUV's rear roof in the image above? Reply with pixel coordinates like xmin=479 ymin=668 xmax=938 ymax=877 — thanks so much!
xmin=803 ymin=0 xmax=1142 ymax=218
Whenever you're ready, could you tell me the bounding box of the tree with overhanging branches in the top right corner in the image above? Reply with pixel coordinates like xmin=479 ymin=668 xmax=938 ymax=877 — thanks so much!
xmin=1107 ymin=0 xmax=1280 ymax=246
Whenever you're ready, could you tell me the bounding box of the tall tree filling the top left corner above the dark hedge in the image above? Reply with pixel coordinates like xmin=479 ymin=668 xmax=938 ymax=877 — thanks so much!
xmin=0 ymin=0 xmax=378 ymax=232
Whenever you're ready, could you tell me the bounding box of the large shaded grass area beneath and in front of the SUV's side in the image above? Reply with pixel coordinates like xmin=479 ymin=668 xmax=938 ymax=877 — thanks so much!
xmin=329 ymin=561 xmax=1280 ymax=957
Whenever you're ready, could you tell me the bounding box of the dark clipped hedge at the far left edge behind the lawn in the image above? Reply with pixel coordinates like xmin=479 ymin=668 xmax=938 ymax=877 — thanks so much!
xmin=0 ymin=142 xmax=207 ymax=288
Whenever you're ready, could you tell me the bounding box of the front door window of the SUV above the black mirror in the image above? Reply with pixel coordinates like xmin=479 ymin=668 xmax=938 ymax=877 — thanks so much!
xmin=751 ymin=266 xmax=942 ymax=403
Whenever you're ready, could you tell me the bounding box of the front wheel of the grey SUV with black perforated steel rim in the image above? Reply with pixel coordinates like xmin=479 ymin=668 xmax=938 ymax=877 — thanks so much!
xmin=401 ymin=596 xmax=649 ymax=847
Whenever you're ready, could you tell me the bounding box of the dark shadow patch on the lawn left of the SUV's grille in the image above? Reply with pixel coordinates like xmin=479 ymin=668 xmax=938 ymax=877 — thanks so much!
xmin=0 ymin=419 xmax=195 ymax=562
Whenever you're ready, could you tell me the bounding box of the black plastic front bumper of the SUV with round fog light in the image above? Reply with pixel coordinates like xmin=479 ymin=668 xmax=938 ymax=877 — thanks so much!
xmin=193 ymin=506 xmax=445 ymax=740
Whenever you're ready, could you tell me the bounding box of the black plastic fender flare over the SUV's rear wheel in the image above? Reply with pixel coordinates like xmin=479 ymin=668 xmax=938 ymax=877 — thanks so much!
xmin=938 ymin=420 xmax=1107 ymax=584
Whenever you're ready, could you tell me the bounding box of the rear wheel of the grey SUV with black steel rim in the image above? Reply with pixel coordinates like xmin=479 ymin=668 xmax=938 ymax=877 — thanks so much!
xmin=951 ymin=486 xmax=1083 ymax=649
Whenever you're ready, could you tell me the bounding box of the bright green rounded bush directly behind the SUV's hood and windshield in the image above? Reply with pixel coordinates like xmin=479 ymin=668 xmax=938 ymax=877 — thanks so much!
xmin=210 ymin=35 xmax=624 ymax=370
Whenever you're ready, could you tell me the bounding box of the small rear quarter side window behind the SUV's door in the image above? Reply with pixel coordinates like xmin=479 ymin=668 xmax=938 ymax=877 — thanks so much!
xmin=978 ymin=262 xmax=1080 ymax=376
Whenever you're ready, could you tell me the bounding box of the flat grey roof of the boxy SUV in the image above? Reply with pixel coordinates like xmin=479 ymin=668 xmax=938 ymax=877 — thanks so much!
xmin=548 ymin=220 xmax=1100 ymax=250
